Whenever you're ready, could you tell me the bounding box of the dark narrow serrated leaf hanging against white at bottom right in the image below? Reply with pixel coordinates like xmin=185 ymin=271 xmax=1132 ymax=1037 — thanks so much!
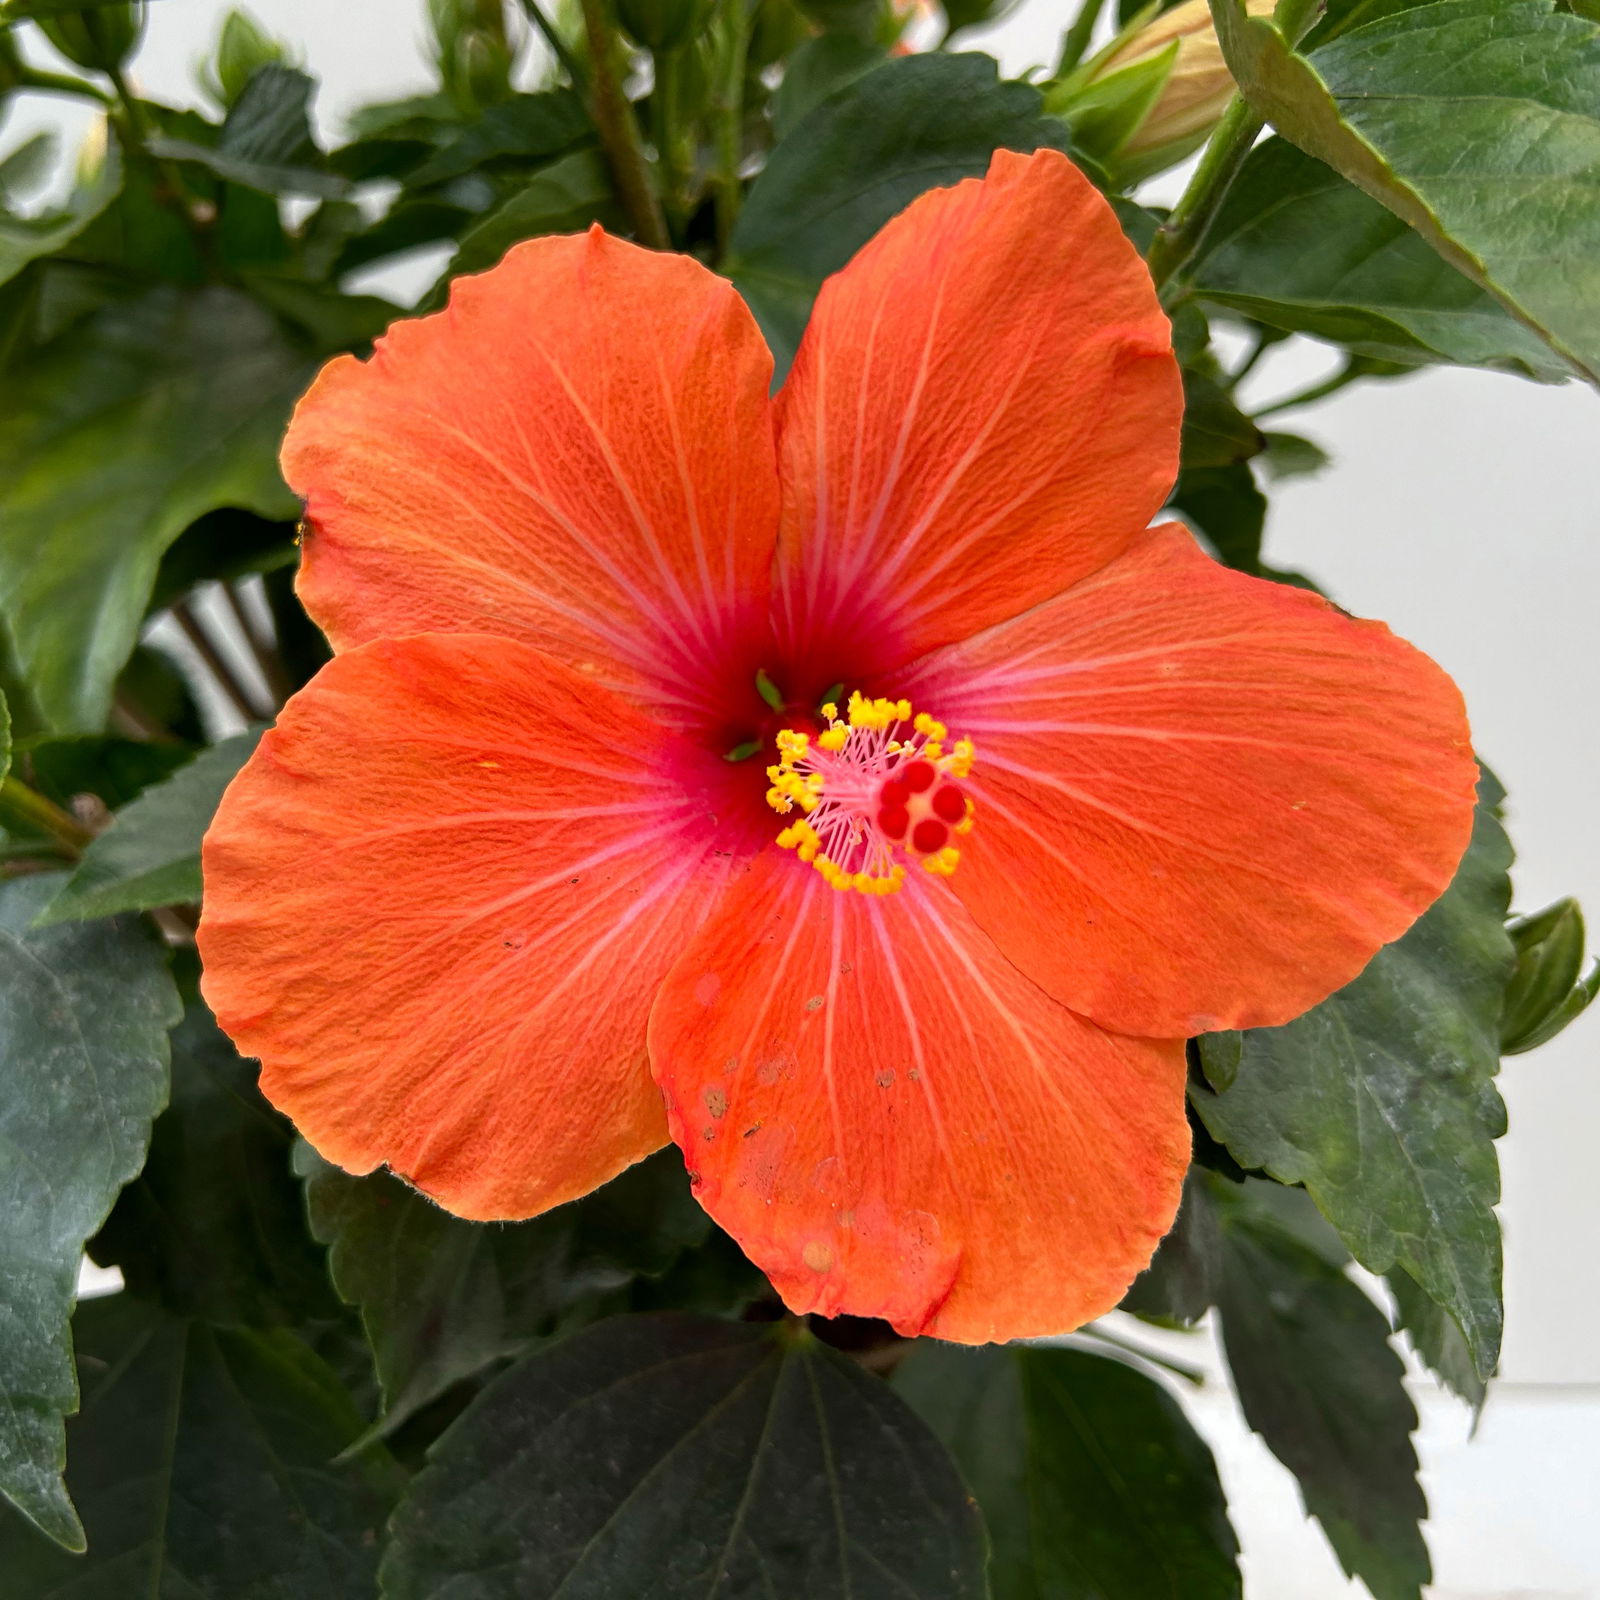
xmin=1205 ymin=1176 xmax=1430 ymax=1600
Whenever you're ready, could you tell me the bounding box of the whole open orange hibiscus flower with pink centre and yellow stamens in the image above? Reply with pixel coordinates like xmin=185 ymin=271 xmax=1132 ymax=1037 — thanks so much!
xmin=200 ymin=152 xmax=1475 ymax=1342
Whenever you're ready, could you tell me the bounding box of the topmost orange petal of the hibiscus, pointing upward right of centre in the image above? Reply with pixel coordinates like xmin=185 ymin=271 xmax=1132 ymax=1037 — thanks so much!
xmin=778 ymin=150 xmax=1182 ymax=677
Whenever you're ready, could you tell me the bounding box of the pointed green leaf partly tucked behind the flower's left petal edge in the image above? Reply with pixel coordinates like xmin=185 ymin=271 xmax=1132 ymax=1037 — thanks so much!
xmin=38 ymin=728 xmax=261 ymax=928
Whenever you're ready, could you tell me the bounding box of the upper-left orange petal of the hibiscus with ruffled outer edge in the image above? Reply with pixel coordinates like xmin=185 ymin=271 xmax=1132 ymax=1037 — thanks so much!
xmin=283 ymin=229 xmax=778 ymax=723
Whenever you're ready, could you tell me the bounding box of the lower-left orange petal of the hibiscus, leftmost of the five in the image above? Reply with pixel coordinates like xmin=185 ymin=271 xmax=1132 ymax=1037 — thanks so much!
xmin=200 ymin=634 xmax=739 ymax=1219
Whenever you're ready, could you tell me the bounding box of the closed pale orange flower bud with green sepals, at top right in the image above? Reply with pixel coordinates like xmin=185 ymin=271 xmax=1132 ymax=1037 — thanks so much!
xmin=1046 ymin=0 xmax=1275 ymax=182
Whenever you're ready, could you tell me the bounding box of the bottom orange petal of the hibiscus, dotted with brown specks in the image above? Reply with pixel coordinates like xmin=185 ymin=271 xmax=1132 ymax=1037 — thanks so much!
xmin=650 ymin=853 xmax=1189 ymax=1344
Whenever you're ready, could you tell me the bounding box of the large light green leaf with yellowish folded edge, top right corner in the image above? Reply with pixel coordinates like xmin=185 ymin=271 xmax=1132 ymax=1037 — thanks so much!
xmin=1211 ymin=0 xmax=1600 ymax=382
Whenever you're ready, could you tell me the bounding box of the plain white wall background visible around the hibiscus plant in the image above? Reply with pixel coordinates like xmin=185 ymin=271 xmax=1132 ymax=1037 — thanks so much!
xmin=12 ymin=0 xmax=1600 ymax=1600
